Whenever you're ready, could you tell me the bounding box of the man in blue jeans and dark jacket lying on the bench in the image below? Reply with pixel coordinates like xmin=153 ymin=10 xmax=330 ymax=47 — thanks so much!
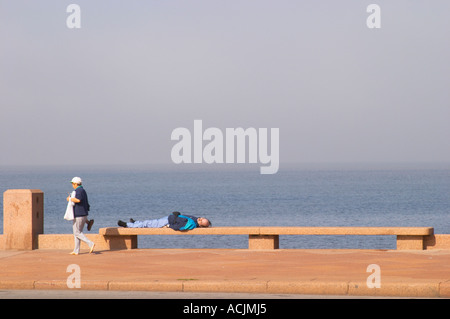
xmin=117 ymin=212 xmax=211 ymax=230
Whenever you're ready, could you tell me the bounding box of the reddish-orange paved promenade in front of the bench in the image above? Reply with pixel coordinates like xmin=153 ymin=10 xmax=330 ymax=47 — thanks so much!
xmin=0 ymin=249 xmax=450 ymax=298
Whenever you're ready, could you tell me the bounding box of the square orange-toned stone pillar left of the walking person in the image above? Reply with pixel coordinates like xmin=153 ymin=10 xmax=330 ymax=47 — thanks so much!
xmin=3 ymin=189 xmax=44 ymax=250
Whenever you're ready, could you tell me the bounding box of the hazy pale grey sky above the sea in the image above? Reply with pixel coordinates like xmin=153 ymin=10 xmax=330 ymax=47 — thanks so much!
xmin=0 ymin=0 xmax=450 ymax=168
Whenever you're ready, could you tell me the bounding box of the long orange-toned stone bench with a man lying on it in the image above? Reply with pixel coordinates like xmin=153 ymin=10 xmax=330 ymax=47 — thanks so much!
xmin=99 ymin=226 xmax=434 ymax=250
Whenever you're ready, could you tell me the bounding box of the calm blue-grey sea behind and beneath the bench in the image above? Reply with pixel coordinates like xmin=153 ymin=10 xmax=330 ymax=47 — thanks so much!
xmin=0 ymin=167 xmax=450 ymax=249
